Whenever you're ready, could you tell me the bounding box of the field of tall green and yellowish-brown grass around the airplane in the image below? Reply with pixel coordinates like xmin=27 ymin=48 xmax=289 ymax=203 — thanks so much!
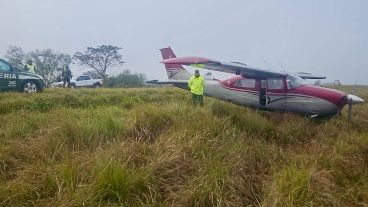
xmin=0 ymin=87 xmax=368 ymax=206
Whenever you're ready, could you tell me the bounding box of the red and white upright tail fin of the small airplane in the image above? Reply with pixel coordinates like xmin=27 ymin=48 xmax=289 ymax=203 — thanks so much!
xmin=160 ymin=47 xmax=192 ymax=80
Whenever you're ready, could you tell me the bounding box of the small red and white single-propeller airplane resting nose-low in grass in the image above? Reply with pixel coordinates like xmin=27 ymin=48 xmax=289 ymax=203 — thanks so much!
xmin=148 ymin=47 xmax=365 ymax=117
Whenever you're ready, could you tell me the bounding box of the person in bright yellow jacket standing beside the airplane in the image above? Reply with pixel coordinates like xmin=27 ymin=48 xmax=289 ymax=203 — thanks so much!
xmin=188 ymin=70 xmax=204 ymax=106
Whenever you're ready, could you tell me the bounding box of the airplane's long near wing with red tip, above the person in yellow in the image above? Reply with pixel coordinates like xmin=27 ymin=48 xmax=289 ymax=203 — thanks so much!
xmin=162 ymin=57 xmax=285 ymax=78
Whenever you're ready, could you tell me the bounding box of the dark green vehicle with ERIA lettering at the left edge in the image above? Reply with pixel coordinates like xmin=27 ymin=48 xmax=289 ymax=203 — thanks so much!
xmin=0 ymin=58 xmax=45 ymax=93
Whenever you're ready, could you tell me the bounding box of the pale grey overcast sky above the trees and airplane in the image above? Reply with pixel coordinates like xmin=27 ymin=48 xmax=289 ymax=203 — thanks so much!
xmin=0 ymin=0 xmax=368 ymax=84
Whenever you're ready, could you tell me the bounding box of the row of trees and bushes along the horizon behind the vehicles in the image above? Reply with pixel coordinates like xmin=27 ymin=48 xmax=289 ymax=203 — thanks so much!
xmin=4 ymin=45 xmax=146 ymax=87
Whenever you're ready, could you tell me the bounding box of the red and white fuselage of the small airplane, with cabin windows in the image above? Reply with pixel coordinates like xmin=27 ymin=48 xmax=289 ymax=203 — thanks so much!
xmin=174 ymin=75 xmax=347 ymax=115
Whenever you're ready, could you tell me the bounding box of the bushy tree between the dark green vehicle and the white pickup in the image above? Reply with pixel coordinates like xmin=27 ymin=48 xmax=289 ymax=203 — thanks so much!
xmin=29 ymin=49 xmax=72 ymax=85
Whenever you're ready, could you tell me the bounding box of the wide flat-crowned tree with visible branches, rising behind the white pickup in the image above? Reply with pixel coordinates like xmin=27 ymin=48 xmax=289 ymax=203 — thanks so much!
xmin=73 ymin=45 xmax=124 ymax=80
